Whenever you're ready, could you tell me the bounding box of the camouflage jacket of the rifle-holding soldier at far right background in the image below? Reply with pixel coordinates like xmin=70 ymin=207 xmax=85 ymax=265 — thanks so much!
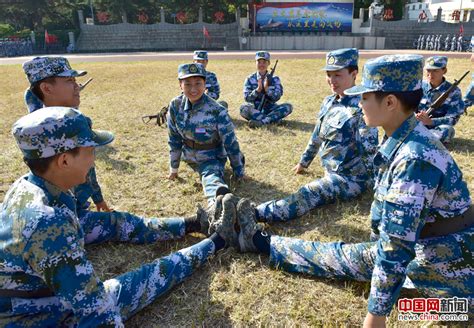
xmin=418 ymin=80 xmax=464 ymax=128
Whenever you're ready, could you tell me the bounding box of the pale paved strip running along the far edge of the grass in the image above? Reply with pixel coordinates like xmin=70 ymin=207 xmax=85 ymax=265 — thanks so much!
xmin=0 ymin=49 xmax=471 ymax=65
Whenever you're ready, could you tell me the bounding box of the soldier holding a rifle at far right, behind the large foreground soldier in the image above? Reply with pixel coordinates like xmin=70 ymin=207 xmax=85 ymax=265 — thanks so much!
xmin=416 ymin=56 xmax=464 ymax=143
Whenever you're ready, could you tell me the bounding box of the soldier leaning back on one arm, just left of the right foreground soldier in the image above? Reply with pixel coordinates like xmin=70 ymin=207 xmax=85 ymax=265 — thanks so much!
xmin=257 ymin=48 xmax=378 ymax=222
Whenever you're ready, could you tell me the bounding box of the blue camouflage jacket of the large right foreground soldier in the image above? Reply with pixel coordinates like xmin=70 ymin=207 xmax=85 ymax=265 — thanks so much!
xmin=369 ymin=115 xmax=472 ymax=315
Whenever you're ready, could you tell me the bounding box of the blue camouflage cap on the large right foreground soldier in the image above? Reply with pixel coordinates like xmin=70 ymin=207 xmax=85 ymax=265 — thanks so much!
xmin=344 ymin=55 xmax=423 ymax=95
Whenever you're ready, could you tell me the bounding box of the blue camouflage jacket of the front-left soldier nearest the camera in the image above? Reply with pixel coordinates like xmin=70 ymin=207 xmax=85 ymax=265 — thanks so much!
xmin=0 ymin=173 xmax=122 ymax=326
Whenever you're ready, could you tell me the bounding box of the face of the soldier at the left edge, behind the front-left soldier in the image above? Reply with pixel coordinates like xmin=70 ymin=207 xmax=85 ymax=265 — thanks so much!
xmin=42 ymin=77 xmax=81 ymax=108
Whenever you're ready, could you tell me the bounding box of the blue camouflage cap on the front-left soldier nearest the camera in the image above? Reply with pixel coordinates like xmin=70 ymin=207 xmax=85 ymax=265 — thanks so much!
xmin=12 ymin=107 xmax=114 ymax=159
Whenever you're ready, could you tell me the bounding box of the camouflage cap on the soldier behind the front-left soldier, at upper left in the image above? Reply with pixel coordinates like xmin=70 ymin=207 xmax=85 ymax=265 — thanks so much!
xmin=23 ymin=57 xmax=87 ymax=84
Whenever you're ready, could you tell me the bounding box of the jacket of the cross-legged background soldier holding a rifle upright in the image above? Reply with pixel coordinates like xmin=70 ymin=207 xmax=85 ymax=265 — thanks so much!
xmin=244 ymin=72 xmax=283 ymax=111
